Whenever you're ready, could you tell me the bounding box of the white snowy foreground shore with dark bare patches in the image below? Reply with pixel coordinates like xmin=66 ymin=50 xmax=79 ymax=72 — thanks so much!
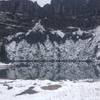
xmin=0 ymin=79 xmax=100 ymax=100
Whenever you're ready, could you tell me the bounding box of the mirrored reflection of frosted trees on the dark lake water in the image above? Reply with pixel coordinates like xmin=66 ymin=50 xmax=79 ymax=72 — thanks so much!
xmin=5 ymin=62 xmax=98 ymax=80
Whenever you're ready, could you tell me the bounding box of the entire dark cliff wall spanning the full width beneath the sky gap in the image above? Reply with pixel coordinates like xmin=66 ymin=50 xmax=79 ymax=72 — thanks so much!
xmin=0 ymin=0 xmax=100 ymax=29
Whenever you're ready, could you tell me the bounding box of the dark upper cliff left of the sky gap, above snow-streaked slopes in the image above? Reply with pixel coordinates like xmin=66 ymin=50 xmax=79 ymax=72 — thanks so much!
xmin=0 ymin=0 xmax=41 ymax=17
